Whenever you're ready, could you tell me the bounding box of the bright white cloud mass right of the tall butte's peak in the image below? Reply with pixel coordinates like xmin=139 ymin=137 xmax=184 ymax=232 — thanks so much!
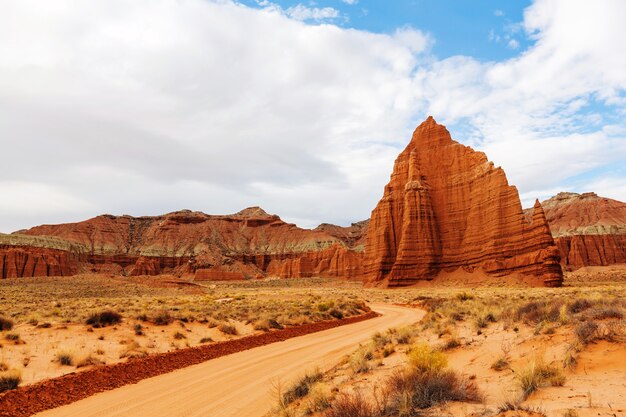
xmin=420 ymin=0 xmax=626 ymax=204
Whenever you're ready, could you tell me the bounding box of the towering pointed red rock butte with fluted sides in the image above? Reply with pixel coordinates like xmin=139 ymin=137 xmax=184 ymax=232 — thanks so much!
xmin=364 ymin=117 xmax=562 ymax=286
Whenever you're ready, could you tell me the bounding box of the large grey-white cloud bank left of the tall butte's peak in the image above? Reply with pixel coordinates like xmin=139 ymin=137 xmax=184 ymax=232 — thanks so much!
xmin=0 ymin=0 xmax=427 ymax=231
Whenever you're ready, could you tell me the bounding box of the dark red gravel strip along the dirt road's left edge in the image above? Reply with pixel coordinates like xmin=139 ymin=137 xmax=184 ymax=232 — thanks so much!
xmin=0 ymin=311 xmax=378 ymax=417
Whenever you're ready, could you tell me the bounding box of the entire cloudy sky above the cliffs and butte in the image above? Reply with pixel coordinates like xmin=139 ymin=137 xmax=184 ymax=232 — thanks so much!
xmin=0 ymin=0 xmax=626 ymax=233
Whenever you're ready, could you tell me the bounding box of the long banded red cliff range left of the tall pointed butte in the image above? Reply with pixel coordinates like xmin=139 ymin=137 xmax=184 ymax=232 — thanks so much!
xmin=0 ymin=207 xmax=367 ymax=279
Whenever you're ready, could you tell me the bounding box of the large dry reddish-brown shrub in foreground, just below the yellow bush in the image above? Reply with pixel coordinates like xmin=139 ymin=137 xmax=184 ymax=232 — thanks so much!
xmin=387 ymin=368 xmax=483 ymax=415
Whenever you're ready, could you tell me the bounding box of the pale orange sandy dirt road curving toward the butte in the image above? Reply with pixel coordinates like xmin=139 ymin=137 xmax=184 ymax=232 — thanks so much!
xmin=37 ymin=304 xmax=424 ymax=417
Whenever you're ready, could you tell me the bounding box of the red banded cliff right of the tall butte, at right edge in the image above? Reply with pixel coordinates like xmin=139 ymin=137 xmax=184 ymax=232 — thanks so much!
xmin=526 ymin=193 xmax=626 ymax=270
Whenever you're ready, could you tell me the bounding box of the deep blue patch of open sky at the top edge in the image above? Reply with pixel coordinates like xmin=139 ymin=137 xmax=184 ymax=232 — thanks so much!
xmin=242 ymin=0 xmax=532 ymax=60
